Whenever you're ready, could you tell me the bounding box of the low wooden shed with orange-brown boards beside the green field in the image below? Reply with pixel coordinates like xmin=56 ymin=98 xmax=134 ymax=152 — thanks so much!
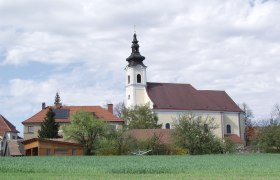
xmin=22 ymin=138 xmax=84 ymax=156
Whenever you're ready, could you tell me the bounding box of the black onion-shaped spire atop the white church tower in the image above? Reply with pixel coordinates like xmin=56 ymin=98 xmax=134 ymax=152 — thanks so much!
xmin=126 ymin=33 xmax=145 ymax=66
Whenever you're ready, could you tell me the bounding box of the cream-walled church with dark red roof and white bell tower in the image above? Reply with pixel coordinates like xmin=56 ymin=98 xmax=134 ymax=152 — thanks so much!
xmin=125 ymin=33 xmax=245 ymax=141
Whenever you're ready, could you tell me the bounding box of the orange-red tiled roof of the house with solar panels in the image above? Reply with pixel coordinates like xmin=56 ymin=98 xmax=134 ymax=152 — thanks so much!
xmin=22 ymin=106 xmax=123 ymax=124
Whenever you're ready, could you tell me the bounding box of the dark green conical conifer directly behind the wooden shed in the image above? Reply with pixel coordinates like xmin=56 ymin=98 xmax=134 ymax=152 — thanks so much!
xmin=38 ymin=108 xmax=59 ymax=138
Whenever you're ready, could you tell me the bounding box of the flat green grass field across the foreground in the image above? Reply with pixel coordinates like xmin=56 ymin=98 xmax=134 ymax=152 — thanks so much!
xmin=0 ymin=154 xmax=280 ymax=180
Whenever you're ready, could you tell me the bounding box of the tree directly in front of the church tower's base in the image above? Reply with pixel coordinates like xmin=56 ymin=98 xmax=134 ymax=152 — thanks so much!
xmin=122 ymin=104 xmax=162 ymax=129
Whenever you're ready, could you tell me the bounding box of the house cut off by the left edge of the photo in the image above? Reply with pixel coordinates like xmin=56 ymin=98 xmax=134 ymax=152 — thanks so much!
xmin=0 ymin=114 xmax=19 ymax=156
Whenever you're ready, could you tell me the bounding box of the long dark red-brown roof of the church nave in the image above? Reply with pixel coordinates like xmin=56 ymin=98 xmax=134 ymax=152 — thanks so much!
xmin=147 ymin=82 xmax=242 ymax=112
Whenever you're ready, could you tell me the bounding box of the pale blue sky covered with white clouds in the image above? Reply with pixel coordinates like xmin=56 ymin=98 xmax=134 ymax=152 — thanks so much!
xmin=0 ymin=0 xmax=280 ymax=132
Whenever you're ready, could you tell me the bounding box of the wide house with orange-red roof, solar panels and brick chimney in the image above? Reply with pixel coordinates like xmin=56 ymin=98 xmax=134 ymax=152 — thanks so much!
xmin=22 ymin=103 xmax=124 ymax=139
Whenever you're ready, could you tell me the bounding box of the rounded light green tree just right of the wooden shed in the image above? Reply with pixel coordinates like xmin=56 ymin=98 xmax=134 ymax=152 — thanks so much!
xmin=63 ymin=111 xmax=107 ymax=155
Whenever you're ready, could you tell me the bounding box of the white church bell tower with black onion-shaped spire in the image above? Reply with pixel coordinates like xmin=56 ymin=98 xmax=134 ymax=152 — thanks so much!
xmin=125 ymin=33 xmax=147 ymax=107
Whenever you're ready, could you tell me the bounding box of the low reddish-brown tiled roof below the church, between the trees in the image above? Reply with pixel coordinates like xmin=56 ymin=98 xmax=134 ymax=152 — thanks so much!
xmin=128 ymin=129 xmax=173 ymax=144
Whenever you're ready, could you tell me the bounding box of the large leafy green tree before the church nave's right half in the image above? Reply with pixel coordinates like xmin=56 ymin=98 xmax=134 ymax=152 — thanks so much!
xmin=172 ymin=114 xmax=222 ymax=155
